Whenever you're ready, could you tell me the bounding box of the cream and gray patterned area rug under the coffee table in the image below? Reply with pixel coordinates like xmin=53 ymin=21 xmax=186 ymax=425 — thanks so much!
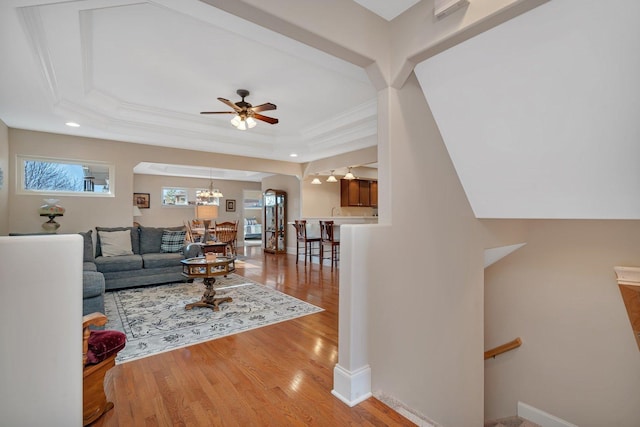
xmin=105 ymin=274 xmax=323 ymax=363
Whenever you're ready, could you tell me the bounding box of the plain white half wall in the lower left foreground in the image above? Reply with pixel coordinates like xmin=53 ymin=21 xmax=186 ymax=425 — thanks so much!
xmin=0 ymin=235 xmax=83 ymax=427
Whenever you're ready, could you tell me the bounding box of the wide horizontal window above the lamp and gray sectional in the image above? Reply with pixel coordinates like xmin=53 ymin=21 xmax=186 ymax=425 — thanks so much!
xmin=18 ymin=156 xmax=115 ymax=196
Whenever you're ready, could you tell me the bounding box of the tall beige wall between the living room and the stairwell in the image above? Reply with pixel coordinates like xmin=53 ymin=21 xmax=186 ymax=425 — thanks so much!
xmin=368 ymin=76 xmax=483 ymax=427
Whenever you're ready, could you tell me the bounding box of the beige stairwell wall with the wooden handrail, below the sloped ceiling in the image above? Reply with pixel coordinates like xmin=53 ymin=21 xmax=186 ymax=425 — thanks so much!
xmin=483 ymin=220 xmax=640 ymax=427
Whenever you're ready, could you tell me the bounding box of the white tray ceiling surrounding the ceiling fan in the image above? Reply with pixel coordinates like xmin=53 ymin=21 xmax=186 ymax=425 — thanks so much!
xmin=0 ymin=0 xmax=377 ymax=180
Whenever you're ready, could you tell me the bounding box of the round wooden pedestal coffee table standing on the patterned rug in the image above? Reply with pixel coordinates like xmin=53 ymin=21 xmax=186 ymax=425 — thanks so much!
xmin=180 ymin=256 xmax=236 ymax=311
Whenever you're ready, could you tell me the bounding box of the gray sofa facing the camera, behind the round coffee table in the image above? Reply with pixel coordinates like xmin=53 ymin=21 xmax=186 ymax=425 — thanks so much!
xmin=95 ymin=226 xmax=185 ymax=290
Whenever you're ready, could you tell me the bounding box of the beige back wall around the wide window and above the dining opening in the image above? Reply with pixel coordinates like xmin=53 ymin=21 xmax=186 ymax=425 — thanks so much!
xmin=8 ymin=129 xmax=301 ymax=233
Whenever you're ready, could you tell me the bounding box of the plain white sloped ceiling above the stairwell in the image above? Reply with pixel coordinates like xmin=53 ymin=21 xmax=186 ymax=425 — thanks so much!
xmin=416 ymin=0 xmax=640 ymax=219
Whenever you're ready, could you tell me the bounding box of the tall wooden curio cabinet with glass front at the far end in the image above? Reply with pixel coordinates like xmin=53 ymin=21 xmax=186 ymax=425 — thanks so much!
xmin=263 ymin=189 xmax=287 ymax=254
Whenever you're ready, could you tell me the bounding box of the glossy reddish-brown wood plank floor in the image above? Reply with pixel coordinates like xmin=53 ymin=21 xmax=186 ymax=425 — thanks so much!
xmin=93 ymin=247 xmax=414 ymax=427
